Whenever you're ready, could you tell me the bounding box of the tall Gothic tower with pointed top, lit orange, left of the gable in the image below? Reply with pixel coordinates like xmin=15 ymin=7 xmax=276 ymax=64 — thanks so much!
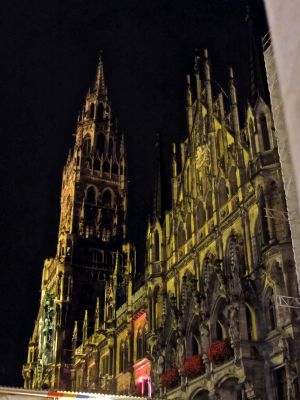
xmin=23 ymin=57 xmax=130 ymax=389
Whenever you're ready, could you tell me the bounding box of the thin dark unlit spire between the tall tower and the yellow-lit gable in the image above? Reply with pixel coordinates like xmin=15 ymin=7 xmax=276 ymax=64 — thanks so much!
xmin=153 ymin=132 xmax=167 ymax=219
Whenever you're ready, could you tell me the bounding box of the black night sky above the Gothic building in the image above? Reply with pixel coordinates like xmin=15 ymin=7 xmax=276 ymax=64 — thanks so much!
xmin=0 ymin=0 xmax=266 ymax=386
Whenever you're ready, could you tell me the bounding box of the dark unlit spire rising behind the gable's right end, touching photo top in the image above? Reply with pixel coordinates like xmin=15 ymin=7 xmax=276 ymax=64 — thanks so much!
xmin=245 ymin=2 xmax=266 ymax=107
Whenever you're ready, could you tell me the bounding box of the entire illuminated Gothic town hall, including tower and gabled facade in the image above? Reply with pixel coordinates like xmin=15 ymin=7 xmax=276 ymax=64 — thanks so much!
xmin=23 ymin=51 xmax=300 ymax=400
